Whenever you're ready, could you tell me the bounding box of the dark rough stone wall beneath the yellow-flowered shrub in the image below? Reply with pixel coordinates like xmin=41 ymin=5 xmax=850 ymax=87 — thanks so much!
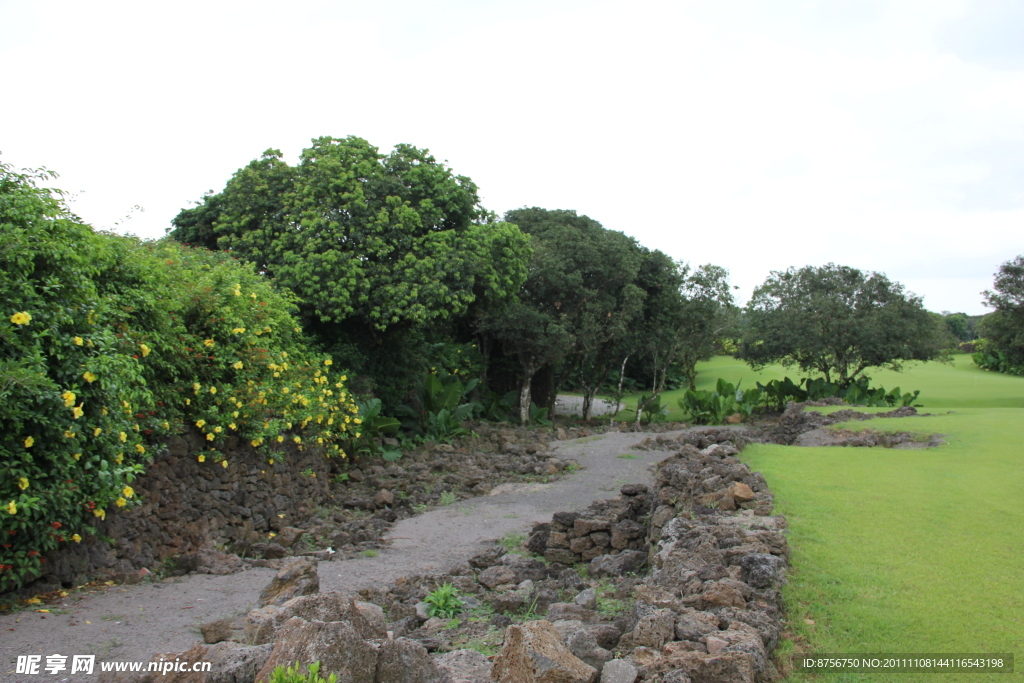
xmin=29 ymin=431 xmax=330 ymax=593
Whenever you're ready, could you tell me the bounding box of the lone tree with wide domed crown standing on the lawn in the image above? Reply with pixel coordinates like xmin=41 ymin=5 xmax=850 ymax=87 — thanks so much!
xmin=740 ymin=263 xmax=949 ymax=386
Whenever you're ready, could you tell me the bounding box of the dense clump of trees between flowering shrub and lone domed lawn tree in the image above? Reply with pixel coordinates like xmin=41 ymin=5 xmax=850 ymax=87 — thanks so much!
xmin=170 ymin=137 xmax=735 ymax=422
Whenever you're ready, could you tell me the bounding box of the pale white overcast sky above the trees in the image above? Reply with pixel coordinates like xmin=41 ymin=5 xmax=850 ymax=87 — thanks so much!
xmin=0 ymin=0 xmax=1024 ymax=313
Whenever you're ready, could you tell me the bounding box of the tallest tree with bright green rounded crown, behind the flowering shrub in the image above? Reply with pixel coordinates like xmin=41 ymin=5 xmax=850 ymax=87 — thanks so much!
xmin=171 ymin=137 xmax=530 ymax=404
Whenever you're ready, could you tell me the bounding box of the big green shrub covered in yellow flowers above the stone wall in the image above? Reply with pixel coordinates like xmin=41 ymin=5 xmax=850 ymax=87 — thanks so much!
xmin=0 ymin=165 xmax=359 ymax=591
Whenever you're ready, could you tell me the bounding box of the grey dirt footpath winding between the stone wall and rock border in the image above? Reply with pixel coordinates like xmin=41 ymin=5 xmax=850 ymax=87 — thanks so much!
xmin=0 ymin=432 xmax=688 ymax=682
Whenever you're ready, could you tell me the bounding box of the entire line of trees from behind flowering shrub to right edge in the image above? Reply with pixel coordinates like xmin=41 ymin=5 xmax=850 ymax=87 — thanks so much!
xmin=170 ymin=137 xmax=1016 ymax=423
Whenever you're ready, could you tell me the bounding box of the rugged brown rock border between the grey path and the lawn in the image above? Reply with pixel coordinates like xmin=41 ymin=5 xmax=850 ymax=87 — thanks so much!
xmin=101 ymin=442 xmax=788 ymax=683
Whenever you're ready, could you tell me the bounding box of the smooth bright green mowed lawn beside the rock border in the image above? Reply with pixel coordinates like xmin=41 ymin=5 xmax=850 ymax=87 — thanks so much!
xmin=626 ymin=355 xmax=1024 ymax=682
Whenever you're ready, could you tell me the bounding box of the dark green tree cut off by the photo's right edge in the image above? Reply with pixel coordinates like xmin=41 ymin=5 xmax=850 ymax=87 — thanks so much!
xmin=976 ymin=256 xmax=1024 ymax=375
